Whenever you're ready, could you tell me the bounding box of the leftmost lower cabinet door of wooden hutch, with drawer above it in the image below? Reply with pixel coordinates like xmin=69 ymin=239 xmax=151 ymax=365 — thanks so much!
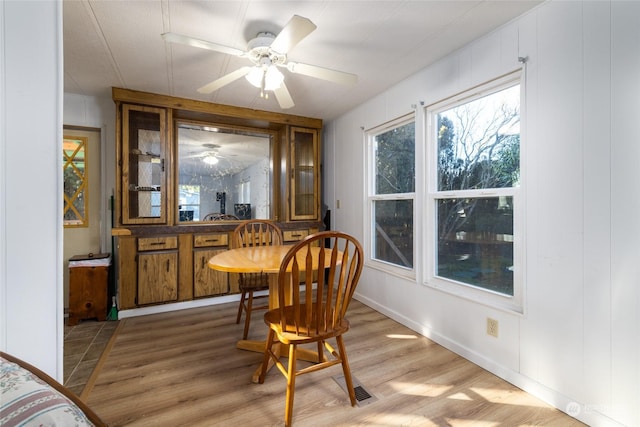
xmin=137 ymin=236 xmax=178 ymax=305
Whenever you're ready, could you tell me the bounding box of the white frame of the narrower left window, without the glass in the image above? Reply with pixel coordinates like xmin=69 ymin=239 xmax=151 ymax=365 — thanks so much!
xmin=364 ymin=112 xmax=421 ymax=280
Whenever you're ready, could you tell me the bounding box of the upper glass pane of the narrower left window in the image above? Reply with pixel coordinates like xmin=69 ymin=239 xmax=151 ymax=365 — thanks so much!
xmin=374 ymin=122 xmax=415 ymax=194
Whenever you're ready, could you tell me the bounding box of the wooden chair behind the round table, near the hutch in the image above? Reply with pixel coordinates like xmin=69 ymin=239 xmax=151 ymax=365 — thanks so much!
xmin=232 ymin=219 xmax=284 ymax=340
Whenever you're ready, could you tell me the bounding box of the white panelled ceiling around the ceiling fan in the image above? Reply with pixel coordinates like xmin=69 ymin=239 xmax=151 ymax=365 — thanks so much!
xmin=63 ymin=0 xmax=541 ymax=120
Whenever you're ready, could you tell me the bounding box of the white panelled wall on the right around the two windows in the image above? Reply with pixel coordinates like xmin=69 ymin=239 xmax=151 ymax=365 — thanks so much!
xmin=324 ymin=1 xmax=640 ymax=426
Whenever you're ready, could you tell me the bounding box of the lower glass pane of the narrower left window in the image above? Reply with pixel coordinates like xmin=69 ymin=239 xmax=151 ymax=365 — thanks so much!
xmin=373 ymin=200 xmax=413 ymax=268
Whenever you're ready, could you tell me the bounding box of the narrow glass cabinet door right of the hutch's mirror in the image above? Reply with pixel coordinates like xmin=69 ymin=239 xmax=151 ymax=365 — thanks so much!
xmin=290 ymin=127 xmax=320 ymax=220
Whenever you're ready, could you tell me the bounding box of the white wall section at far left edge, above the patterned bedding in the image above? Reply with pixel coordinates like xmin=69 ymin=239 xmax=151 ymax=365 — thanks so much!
xmin=0 ymin=1 xmax=63 ymax=380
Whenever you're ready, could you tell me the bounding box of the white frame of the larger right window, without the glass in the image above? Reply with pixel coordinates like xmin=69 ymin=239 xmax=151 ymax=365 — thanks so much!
xmin=423 ymin=70 xmax=526 ymax=314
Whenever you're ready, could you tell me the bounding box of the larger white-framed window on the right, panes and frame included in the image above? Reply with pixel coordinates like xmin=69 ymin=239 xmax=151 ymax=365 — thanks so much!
xmin=426 ymin=74 xmax=522 ymax=309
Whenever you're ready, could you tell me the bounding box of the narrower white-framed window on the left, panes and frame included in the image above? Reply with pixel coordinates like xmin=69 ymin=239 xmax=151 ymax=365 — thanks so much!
xmin=367 ymin=114 xmax=415 ymax=271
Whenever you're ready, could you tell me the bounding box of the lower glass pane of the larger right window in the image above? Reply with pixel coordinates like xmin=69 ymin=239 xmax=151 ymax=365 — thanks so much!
xmin=436 ymin=197 xmax=513 ymax=295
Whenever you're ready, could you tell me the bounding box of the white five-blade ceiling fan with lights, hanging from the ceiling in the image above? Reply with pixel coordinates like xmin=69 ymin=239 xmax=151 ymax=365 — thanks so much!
xmin=162 ymin=15 xmax=358 ymax=109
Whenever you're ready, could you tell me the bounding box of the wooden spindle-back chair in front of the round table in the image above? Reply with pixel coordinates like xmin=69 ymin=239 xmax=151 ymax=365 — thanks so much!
xmin=259 ymin=231 xmax=364 ymax=426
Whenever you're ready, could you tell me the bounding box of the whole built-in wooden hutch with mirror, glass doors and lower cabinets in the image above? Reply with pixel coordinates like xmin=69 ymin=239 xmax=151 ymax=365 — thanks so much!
xmin=112 ymin=88 xmax=322 ymax=310
